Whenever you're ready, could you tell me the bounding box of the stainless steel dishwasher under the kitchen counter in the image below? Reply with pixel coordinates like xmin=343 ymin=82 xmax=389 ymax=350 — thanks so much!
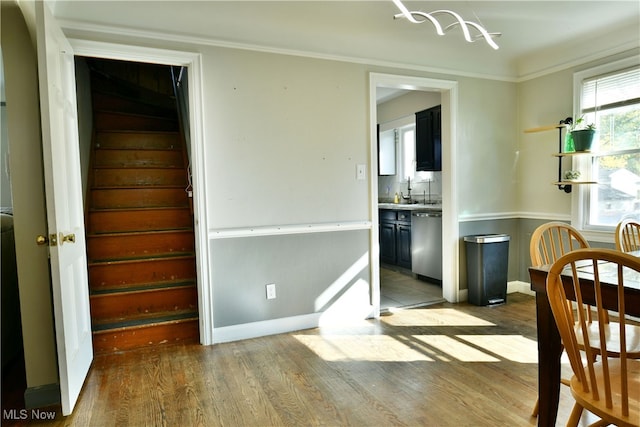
xmin=411 ymin=211 xmax=442 ymax=283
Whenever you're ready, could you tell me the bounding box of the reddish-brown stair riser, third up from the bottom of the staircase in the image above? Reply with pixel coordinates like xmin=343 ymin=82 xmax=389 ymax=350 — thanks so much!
xmin=89 ymin=258 xmax=196 ymax=291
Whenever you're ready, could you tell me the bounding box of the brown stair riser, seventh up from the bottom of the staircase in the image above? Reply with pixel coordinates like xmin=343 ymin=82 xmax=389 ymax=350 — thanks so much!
xmin=93 ymin=169 xmax=187 ymax=188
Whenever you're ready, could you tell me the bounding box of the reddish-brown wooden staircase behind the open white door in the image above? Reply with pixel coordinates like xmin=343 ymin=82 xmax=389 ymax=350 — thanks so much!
xmin=86 ymin=63 xmax=199 ymax=353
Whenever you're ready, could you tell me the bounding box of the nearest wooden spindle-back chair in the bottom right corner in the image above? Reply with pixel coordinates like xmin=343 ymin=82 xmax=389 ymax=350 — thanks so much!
xmin=547 ymin=248 xmax=640 ymax=427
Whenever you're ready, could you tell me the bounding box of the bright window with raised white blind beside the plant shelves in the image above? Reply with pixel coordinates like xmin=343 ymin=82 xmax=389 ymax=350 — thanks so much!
xmin=574 ymin=58 xmax=640 ymax=231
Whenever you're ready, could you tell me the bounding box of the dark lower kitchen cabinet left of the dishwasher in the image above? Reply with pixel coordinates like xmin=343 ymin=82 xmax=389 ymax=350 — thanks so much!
xmin=379 ymin=209 xmax=411 ymax=269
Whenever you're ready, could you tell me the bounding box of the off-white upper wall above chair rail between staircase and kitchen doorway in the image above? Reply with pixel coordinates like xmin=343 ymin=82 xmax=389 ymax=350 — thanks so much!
xmin=203 ymin=48 xmax=369 ymax=229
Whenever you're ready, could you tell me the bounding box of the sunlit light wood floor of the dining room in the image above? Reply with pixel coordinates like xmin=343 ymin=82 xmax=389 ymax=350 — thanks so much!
xmin=3 ymin=294 xmax=604 ymax=427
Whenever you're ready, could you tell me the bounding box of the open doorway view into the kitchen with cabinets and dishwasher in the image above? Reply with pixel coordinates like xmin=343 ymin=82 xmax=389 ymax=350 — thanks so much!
xmin=376 ymin=88 xmax=444 ymax=311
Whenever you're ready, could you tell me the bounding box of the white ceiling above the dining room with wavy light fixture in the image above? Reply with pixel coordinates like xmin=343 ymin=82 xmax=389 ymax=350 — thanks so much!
xmin=53 ymin=0 xmax=640 ymax=81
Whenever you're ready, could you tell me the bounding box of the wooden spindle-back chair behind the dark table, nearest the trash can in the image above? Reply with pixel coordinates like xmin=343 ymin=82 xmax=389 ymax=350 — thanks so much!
xmin=529 ymin=221 xmax=589 ymax=417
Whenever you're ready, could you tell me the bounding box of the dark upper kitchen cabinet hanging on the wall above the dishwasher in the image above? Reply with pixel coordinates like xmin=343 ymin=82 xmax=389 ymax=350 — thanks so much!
xmin=416 ymin=105 xmax=442 ymax=171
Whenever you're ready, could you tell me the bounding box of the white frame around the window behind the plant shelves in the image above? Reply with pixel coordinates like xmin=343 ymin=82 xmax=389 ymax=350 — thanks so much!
xmin=571 ymin=55 xmax=640 ymax=243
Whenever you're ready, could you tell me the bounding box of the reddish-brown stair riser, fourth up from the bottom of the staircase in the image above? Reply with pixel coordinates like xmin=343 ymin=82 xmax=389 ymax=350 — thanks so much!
xmin=87 ymin=230 xmax=194 ymax=260
